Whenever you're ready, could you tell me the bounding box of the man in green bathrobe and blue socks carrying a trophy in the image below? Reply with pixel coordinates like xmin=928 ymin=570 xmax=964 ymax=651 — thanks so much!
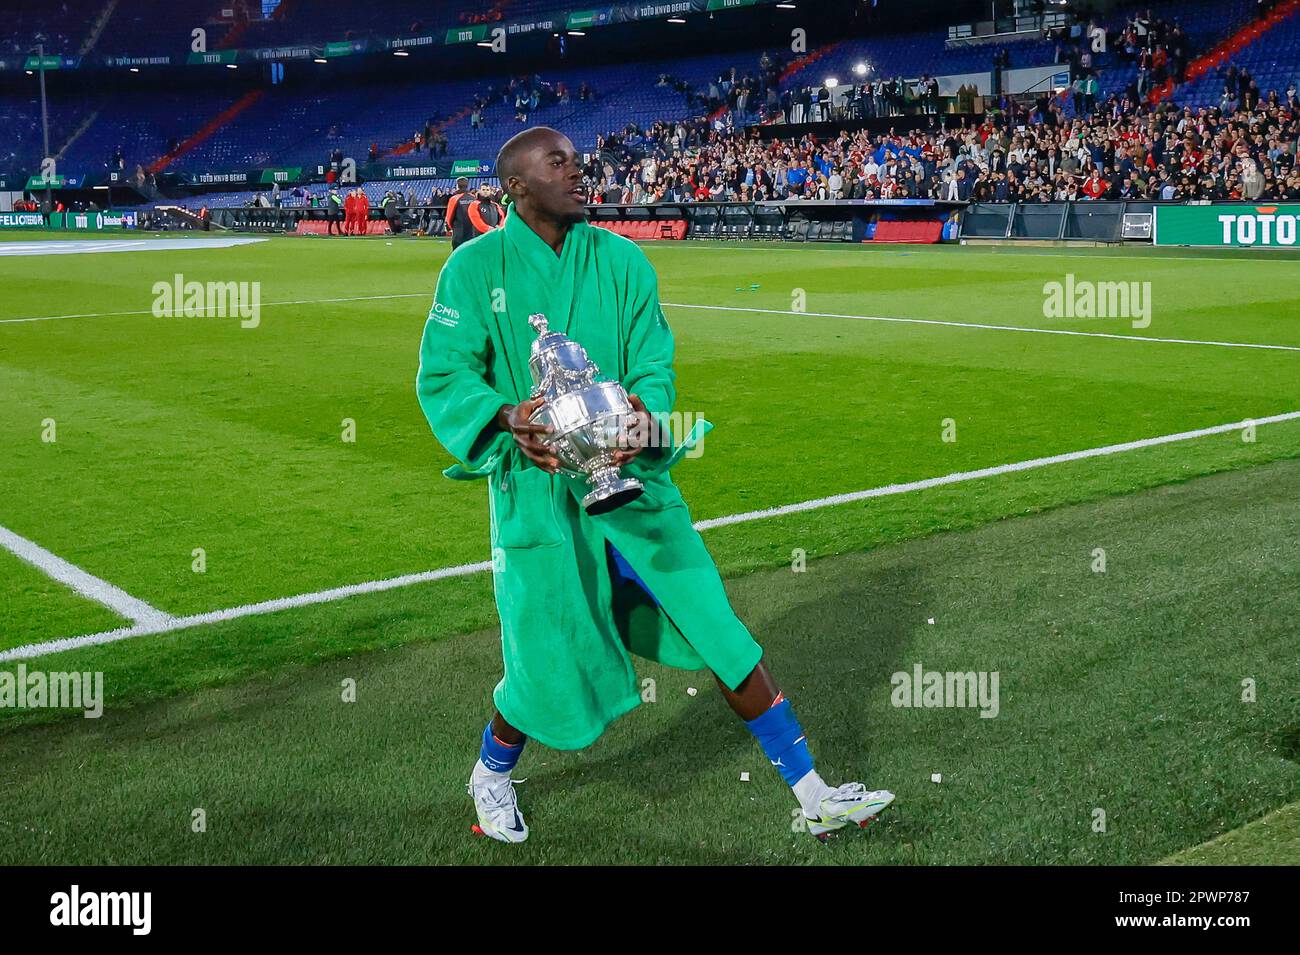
xmin=416 ymin=127 xmax=893 ymax=842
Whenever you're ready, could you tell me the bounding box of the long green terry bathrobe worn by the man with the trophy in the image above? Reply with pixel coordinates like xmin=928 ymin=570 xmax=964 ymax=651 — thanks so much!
xmin=416 ymin=213 xmax=762 ymax=750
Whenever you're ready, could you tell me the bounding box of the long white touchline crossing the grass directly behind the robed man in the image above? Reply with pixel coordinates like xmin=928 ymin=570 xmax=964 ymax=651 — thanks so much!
xmin=0 ymin=411 xmax=1300 ymax=663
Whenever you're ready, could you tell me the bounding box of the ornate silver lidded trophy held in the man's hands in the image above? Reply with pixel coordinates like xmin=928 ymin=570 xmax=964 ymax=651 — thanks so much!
xmin=528 ymin=313 xmax=645 ymax=515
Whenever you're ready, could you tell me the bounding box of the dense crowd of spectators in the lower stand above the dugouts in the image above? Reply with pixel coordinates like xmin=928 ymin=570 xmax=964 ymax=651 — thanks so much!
xmin=585 ymin=68 xmax=1300 ymax=204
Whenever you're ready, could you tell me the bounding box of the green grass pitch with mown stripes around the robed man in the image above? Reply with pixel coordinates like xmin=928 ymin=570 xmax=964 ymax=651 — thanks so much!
xmin=0 ymin=236 xmax=1300 ymax=863
